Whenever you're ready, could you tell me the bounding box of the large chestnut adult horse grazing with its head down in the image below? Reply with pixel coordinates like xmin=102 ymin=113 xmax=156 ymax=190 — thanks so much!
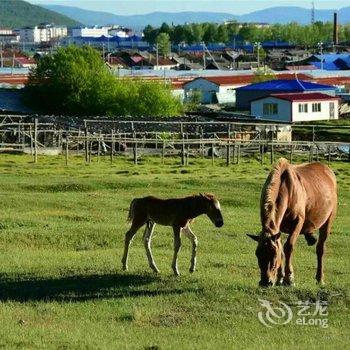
xmin=248 ymin=158 xmax=337 ymax=286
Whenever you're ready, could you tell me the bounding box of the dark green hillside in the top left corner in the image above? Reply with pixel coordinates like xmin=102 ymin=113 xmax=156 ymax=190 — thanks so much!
xmin=0 ymin=0 xmax=79 ymax=28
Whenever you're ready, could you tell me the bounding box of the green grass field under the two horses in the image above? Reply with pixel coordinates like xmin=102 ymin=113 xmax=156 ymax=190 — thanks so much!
xmin=0 ymin=154 xmax=350 ymax=349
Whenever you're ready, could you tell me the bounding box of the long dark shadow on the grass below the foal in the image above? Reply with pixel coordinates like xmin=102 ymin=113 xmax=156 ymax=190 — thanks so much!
xmin=0 ymin=274 xmax=197 ymax=302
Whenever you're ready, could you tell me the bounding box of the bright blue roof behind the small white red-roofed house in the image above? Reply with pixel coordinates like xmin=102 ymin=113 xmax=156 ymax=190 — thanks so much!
xmin=237 ymin=79 xmax=335 ymax=92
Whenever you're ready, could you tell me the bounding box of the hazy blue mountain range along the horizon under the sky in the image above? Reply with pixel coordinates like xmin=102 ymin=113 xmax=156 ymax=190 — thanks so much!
xmin=43 ymin=5 xmax=350 ymax=28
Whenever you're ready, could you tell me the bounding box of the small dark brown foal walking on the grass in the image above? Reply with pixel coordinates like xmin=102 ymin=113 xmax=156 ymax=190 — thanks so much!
xmin=122 ymin=193 xmax=224 ymax=276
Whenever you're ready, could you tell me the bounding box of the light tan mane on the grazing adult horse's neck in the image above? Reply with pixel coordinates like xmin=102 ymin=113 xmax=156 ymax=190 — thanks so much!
xmin=260 ymin=158 xmax=289 ymax=227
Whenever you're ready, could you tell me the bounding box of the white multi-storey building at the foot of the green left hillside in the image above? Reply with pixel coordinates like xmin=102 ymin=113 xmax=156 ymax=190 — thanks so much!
xmin=19 ymin=24 xmax=68 ymax=43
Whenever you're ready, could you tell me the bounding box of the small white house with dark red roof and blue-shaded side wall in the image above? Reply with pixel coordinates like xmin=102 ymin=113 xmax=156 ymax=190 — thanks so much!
xmin=250 ymin=92 xmax=339 ymax=123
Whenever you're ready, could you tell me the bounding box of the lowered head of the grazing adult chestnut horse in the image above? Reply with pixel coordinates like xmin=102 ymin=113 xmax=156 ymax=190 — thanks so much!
xmin=248 ymin=233 xmax=283 ymax=287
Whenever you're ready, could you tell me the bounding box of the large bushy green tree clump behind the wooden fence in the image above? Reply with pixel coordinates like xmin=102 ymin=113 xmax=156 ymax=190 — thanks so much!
xmin=25 ymin=46 xmax=182 ymax=116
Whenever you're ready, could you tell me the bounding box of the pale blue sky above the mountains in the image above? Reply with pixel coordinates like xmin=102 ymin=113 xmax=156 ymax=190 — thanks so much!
xmin=29 ymin=0 xmax=350 ymax=15
